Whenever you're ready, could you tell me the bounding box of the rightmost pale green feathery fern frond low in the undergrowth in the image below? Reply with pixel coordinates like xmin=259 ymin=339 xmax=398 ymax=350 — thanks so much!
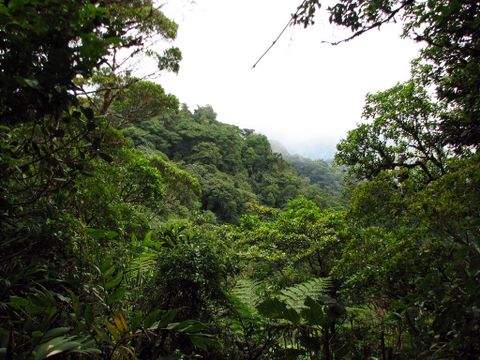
xmin=278 ymin=278 xmax=332 ymax=313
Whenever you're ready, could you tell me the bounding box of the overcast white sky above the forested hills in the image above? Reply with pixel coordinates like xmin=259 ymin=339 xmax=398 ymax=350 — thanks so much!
xmin=159 ymin=0 xmax=418 ymax=157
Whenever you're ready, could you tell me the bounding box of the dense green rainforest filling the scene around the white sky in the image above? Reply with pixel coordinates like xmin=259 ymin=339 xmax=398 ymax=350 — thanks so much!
xmin=0 ymin=0 xmax=480 ymax=360
